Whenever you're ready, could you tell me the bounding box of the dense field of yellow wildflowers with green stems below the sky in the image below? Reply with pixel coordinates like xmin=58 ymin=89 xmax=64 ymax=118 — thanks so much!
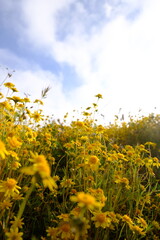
xmin=0 ymin=79 xmax=160 ymax=240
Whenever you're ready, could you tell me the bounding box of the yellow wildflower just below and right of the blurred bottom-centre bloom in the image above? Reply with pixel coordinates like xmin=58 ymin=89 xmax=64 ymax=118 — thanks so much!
xmin=92 ymin=212 xmax=111 ymax=228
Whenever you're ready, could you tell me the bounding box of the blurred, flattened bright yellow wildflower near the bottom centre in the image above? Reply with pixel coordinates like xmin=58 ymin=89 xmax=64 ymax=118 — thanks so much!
xmin=71 ymin=192 xmax=97 ymax=209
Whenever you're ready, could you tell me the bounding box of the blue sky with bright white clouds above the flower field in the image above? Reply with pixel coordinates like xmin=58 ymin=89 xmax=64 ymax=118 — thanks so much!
xmin=0 ymin=0 xmax=160 ymax=121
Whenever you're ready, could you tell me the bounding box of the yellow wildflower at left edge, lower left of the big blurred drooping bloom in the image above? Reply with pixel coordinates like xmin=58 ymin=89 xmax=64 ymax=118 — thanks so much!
xmin=0 ymin=178 xmax=21 ymax=197
